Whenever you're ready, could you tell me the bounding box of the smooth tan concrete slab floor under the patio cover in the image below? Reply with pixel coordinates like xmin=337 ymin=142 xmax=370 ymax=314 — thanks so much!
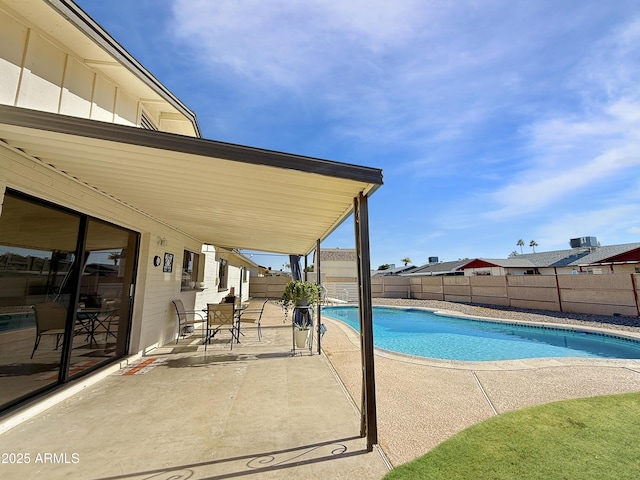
xmin=0 ymin=304 xmax=388 ymax=480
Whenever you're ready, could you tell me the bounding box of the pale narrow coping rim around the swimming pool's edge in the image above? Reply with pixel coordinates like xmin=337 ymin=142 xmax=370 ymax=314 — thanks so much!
xmin=323 ymin=305 xmax=640 ymax=370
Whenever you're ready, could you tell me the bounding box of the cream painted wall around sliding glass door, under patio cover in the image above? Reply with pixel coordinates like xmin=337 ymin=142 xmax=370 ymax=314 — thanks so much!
xmin=0 ymin=142 xmax=208 ymax=353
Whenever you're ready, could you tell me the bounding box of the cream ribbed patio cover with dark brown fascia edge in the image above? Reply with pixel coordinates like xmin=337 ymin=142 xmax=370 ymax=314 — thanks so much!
xmin=0 ymin=105 xmax=382 ymax=254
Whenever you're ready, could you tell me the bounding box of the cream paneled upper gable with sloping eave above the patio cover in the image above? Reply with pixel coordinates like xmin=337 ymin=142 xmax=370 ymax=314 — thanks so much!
xmin=0 ymin=0 xmax=200 ymax=136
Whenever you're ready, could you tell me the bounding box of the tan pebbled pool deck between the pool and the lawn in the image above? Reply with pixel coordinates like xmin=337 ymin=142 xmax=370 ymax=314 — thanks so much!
xmin=323 ymin=301 xmax=640 ymax=466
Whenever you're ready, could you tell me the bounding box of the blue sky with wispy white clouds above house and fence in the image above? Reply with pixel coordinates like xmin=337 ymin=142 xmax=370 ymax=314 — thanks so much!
xmin=76 ymin=0 xmax=640 ymax=268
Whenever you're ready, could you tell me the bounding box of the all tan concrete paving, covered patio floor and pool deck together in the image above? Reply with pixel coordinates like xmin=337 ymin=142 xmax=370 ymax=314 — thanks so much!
xmin=0 ymin=301 xmax=640 ymax=480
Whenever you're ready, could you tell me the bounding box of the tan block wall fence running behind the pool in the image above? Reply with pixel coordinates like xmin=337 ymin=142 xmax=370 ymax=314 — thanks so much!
xmin=250 ymin=273 xmax=640 ymax=317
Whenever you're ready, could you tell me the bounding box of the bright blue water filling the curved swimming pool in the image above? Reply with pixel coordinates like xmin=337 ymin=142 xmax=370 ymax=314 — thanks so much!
xmin=322 ymin=306 xmax=640 ymax=361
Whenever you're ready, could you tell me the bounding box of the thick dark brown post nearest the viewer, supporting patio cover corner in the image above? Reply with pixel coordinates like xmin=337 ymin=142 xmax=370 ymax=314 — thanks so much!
xmin=353 ymin=192 xmax=378 ymax=451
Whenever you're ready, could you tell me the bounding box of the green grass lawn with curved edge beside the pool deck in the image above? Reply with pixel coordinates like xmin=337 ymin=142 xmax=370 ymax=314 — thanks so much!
xmin=385 ymin=393 xmax=640 ymax=480
